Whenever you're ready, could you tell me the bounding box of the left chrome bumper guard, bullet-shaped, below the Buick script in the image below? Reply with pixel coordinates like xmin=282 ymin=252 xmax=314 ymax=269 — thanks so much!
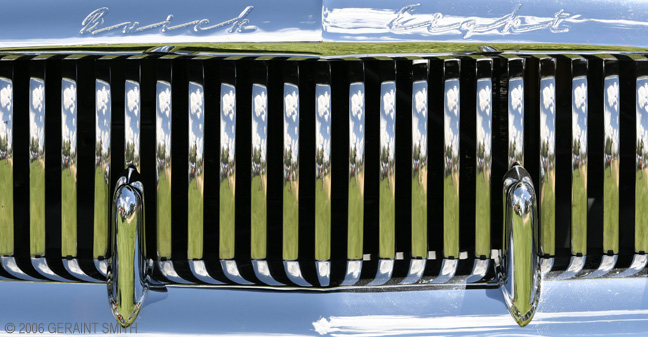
xmin=107 ymin=168 xmax=153 ymax=327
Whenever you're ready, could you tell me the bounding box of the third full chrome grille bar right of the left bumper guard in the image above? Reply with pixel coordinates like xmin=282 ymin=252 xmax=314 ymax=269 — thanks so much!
xmin=219 ymin=83 xmax=237 ymax=259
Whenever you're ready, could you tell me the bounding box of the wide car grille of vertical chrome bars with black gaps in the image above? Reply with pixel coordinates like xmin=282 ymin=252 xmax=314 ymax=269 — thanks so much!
xmin=0 ymin=54 xmax=648 ymax=287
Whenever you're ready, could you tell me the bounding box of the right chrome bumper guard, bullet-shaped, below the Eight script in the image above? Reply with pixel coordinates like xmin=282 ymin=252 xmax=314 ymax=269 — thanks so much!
xmin=495 ymin=165 xmax=542 ymax=326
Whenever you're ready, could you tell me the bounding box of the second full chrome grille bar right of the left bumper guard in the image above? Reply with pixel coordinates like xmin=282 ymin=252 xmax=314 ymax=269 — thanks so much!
xmin=187 ymin=82 xmax=205 ymax=260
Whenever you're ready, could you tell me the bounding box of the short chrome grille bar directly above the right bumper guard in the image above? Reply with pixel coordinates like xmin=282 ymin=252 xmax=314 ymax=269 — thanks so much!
xmin=508 ymin=77 xmax=524 ymax=168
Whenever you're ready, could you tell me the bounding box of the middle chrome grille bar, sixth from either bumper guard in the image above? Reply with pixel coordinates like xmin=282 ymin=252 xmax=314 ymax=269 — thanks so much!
xmin=315 ymin=84 xmax=333 ymax=262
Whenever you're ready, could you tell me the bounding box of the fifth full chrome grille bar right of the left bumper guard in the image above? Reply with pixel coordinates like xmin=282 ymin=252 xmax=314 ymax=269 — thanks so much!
xmin=282 ymin=83 xmax=299 ymax=260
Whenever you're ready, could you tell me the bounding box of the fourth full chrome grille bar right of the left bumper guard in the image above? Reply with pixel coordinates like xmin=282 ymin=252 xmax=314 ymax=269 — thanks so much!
xmin=249 ymin=84 xmax=268 ymax=260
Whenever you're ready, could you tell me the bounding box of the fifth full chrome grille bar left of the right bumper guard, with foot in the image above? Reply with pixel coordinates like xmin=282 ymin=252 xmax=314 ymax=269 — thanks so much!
xmin=342 ymin=82 xmax=365 ymax=285
